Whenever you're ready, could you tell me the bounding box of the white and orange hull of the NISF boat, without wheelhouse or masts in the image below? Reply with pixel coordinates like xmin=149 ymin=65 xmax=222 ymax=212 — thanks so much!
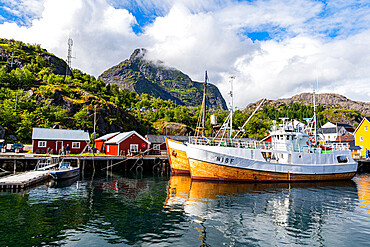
xmin=187 ymin=144 xmax=357 ymax=182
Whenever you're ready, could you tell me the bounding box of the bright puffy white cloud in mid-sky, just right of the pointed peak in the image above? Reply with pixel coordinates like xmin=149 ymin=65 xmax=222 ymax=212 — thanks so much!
xmin=145 ymin=4 xmax=255 ymax=83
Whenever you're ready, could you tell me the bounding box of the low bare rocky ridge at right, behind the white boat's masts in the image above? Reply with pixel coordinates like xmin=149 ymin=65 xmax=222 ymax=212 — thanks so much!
xmin=245 ymin=93 xmax=370 ymax=125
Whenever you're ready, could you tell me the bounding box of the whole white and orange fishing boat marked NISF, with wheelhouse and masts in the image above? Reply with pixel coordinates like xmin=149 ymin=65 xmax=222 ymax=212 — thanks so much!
xmin=186 ymin=79 xmax=357 ymax=182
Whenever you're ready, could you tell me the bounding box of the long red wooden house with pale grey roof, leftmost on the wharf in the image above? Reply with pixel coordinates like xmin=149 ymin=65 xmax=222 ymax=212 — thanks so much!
xmin=32 ymin=128 xmax=90 ymax=154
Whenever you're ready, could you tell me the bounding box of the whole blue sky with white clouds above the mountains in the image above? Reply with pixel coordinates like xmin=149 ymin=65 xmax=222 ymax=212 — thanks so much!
xmin=0 ymin=0 xmax=370 ymax=108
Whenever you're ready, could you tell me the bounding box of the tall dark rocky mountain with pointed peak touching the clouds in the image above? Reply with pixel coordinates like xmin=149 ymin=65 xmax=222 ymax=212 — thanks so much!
xmin=99 ymin=49 xmax=227 ymax=110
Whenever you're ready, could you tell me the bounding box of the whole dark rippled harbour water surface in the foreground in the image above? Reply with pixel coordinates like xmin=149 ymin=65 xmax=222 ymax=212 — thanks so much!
xmin=0 ymin=174 xmax=370 ymax=246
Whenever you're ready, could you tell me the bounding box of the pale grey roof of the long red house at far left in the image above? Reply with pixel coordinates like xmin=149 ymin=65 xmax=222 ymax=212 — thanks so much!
xmin=32 ymin=128 xmax=90 ymax=141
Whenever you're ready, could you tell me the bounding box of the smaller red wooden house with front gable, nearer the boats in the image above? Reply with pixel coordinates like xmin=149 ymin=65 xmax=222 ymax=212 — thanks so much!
xmin=105 ymin=130 xmax=150 ymax=155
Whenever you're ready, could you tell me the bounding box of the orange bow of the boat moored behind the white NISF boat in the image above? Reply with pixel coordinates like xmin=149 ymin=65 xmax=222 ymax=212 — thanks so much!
xmin=166 ymin=138 xmax=190 ymax=174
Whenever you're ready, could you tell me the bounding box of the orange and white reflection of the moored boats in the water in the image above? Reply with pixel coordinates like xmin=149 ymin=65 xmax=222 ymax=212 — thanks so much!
xmin=166 ymin=176 xmax=362 ymax=246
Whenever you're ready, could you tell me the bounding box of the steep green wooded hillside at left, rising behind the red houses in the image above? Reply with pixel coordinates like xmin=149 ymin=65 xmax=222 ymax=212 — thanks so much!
xmin=0 ymin=39 xmax=204 ymax=143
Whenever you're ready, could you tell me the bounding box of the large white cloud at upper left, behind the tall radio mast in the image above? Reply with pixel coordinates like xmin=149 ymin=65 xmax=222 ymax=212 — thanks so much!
xmin=0 ymin=0 xmax=141 ymax=76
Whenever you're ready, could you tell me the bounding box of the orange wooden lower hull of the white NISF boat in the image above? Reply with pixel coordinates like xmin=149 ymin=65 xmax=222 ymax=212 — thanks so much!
xmin=189 ymin=159 xmax=355 ymax=182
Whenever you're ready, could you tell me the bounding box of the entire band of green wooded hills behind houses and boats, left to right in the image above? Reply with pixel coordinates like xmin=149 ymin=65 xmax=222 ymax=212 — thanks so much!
xmin=0 ymin=39 xmax=367 ymax=143
